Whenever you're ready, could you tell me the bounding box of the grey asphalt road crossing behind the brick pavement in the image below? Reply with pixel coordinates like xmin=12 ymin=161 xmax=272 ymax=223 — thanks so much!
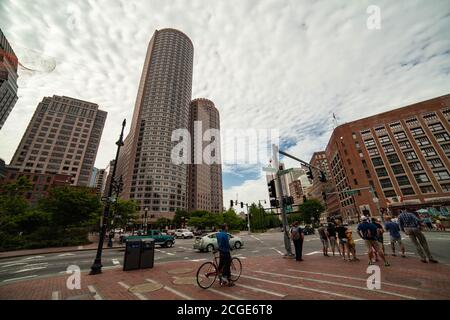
xmin=0 ymin=232 xmax=450 ymax=283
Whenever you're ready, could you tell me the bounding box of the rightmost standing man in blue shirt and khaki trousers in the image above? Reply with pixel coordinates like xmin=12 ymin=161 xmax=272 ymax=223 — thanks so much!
xmin=398 ymin=210 xmax=437 ymax=263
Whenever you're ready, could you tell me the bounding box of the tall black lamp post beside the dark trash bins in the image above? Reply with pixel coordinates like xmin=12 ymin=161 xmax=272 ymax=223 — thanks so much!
xmin=89 ymin=120 xmax=126 ymax=275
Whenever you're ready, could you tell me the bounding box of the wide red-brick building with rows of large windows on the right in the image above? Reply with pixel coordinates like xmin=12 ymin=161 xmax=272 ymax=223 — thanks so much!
xmin=326 ymin=95 xmax=450 ymax=221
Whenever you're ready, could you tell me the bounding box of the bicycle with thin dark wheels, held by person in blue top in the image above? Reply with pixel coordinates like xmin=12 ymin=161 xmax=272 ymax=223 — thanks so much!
xmin=197 ymin=251 xmax=242 ymax=289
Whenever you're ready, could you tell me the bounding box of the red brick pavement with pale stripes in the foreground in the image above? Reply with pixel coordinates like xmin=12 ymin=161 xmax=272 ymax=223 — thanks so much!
xmin=0 ymin=255 xmax=450 ymax=300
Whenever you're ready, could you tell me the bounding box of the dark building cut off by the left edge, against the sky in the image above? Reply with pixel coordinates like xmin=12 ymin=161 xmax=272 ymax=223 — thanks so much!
xmin=0 ymin=29 xmax=19 ymax=130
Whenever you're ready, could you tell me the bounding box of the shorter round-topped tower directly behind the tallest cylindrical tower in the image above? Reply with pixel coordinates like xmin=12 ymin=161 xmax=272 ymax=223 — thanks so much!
xmin=188 ymin=99 xmax=223 ymax=213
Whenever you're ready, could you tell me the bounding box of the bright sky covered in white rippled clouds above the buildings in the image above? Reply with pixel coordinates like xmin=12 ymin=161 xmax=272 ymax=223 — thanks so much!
xmin=0 ymin=0 xmax=450 ymax=208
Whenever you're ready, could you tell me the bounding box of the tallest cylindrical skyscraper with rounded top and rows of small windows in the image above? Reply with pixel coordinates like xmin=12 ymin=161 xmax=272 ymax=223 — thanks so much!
xmin=117 ymin=29 xmax=194 ymax=221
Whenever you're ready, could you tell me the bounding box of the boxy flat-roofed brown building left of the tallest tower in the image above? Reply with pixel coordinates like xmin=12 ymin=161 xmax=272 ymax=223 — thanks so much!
xmin=10 ymin=96 xmax=107 ymax=186
